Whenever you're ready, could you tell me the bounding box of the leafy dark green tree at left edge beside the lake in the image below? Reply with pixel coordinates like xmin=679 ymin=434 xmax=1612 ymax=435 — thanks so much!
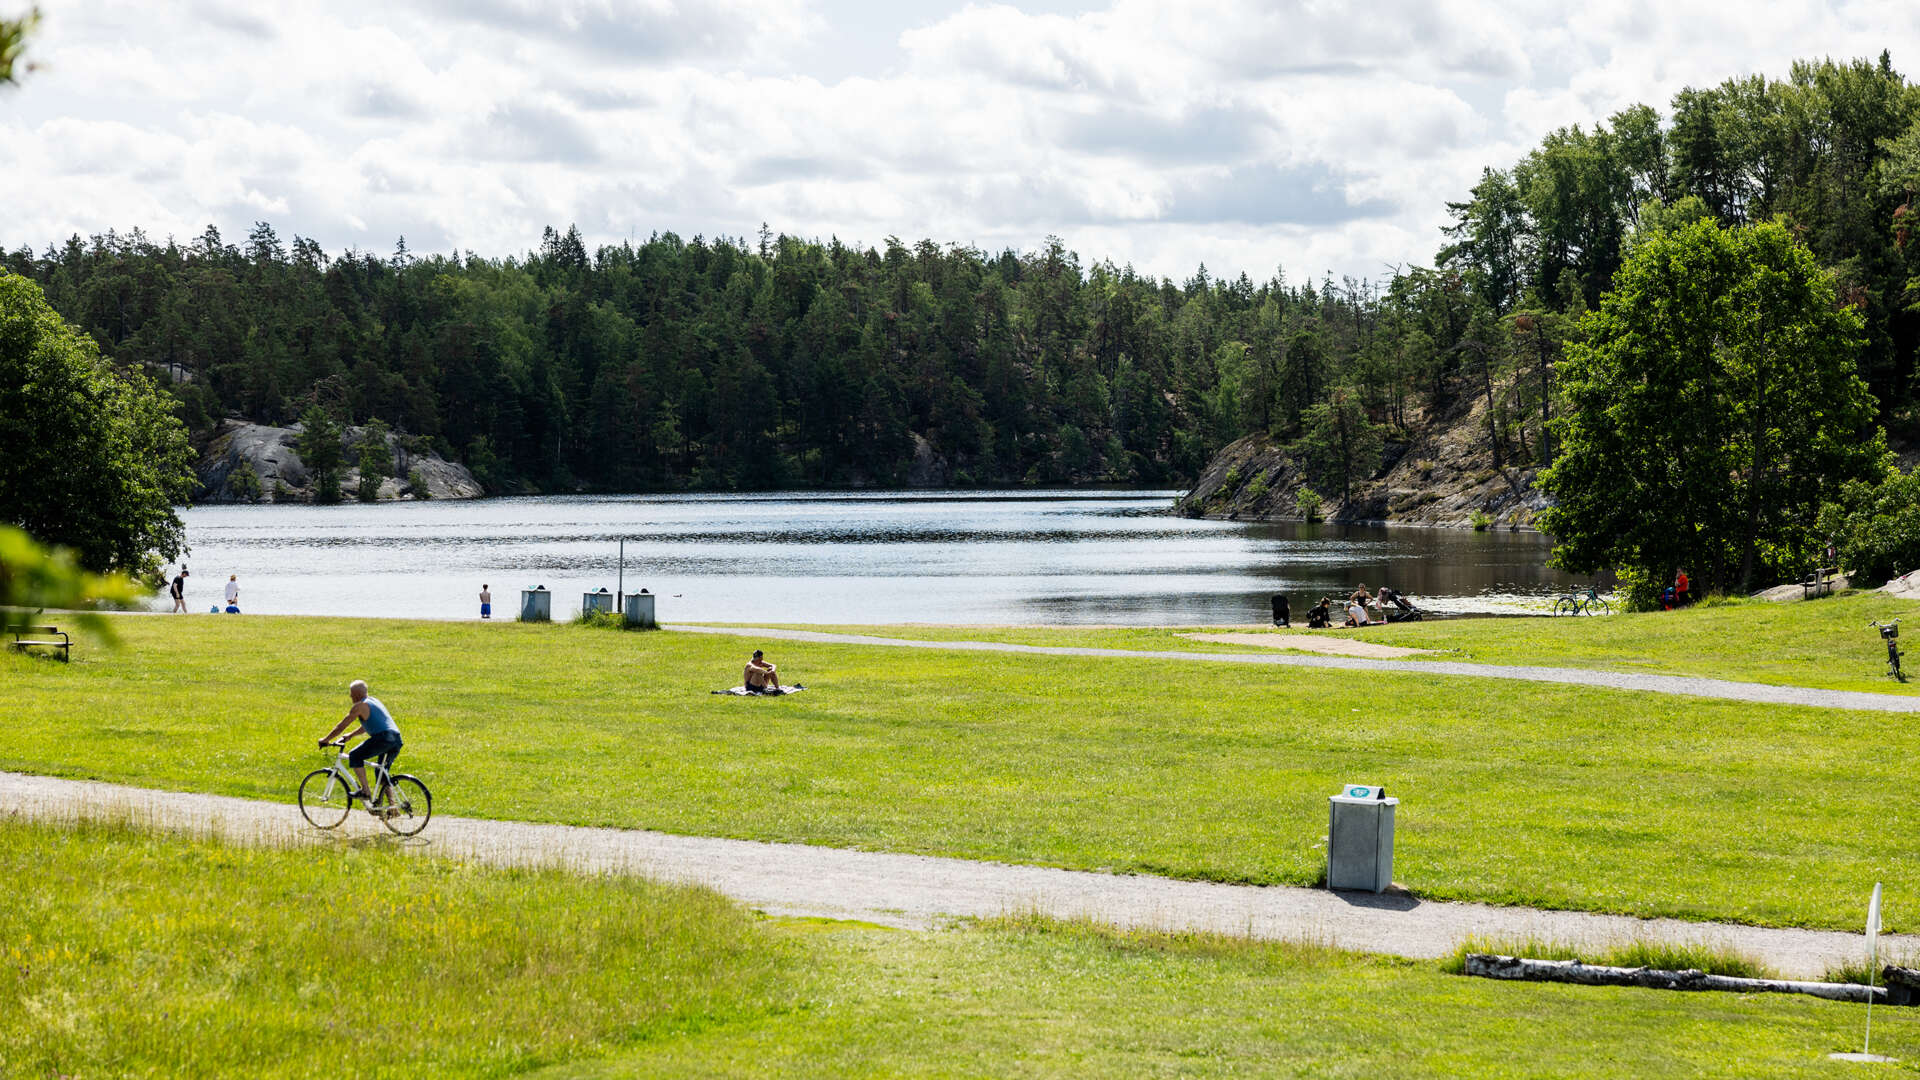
xmin=0 ymin=269 xmax=198 ymax=575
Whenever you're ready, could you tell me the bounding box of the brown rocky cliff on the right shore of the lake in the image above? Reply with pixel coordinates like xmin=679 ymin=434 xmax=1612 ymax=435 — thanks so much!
xmin=1175 ymin=393 xmax=1551 ymax=528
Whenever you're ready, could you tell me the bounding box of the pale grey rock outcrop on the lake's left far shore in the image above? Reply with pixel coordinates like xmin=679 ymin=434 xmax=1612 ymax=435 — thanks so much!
xmin=194 ymin=419 xmax=486 ymax=503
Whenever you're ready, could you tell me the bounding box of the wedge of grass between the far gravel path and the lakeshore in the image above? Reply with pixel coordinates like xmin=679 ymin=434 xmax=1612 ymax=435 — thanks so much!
xmin=744 ymin=590 xmax=1920 ymax=694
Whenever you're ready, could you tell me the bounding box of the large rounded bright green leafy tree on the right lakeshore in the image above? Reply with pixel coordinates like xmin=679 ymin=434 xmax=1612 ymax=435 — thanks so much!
xmin=1540 ymin=221 xmax=1885 ymax=592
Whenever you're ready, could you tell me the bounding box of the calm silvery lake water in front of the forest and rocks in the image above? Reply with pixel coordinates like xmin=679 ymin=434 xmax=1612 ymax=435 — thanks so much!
xmin=165 ymin=490 xmax=1572 ymax=625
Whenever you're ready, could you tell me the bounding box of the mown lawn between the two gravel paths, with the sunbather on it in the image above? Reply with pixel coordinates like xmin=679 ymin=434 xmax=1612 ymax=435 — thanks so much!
xmin=0 ymin=615 xmax=1920 ymax=928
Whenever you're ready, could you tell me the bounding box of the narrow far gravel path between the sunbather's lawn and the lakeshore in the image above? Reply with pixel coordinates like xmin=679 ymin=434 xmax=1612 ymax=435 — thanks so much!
xmin=672 ymin=625 xmax=1920 ymax=713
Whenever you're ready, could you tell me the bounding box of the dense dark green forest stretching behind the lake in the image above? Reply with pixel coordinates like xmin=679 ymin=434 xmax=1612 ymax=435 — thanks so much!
xmin=0 ymin=56 xmax=1920 ymax=503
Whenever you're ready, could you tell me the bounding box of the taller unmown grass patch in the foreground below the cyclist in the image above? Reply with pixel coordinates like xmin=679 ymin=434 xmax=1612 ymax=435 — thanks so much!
xmin=0 ymin=822 xmax=801 ymax=1078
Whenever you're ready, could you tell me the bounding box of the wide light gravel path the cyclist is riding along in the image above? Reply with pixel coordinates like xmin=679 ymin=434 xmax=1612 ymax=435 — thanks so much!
xmin=0 ymin=773 xmax=1889 ymax=978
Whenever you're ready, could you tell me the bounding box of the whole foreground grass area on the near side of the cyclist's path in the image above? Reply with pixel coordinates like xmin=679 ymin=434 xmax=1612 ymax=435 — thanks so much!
xmin=11 ymin=822 xmax=1920 ymax=1080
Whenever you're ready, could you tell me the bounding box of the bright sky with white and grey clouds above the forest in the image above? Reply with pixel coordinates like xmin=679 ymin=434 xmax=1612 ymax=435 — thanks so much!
xmin=0 ymin=0 xmax=1920 ymax=281
